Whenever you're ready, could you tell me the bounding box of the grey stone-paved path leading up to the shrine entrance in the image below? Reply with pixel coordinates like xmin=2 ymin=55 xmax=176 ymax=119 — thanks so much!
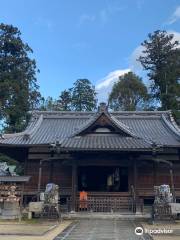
xmin=54 ymin=219 xmax=152 ymax=240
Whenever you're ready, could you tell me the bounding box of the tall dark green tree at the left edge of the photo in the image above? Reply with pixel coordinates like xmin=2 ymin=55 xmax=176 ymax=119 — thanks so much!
xmin=0 ymin=23 xmax=41 ymax=132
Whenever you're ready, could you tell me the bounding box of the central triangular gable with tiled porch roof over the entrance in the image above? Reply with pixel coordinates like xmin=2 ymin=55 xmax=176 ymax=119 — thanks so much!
xmin=60 ymin=111 xmax=152 ymax=151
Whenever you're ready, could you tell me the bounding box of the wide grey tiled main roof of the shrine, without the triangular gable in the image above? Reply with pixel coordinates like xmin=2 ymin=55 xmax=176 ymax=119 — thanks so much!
xmin=0 ymin=111 xmax=180 ymax=149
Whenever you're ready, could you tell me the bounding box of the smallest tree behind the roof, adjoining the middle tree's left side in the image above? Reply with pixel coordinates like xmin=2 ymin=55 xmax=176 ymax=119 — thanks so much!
xmin=57 ymin=89 xmax=72 ymax=111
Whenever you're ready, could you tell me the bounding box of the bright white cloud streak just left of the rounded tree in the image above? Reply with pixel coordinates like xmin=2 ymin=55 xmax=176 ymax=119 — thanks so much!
xmin=96 ymin=68 xmax=131 ymax=102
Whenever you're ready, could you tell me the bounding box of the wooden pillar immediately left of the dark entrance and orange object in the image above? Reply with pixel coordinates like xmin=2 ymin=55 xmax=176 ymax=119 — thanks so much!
xmin=71 ymin=163 xmax=77 ymax=212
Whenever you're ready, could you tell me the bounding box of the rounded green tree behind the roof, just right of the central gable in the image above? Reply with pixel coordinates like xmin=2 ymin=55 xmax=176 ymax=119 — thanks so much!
xmin=109 ymin=72 xmax=148 ymax=111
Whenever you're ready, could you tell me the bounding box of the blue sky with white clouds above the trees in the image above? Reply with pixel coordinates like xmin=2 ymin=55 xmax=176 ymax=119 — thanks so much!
xmin=0 ymin=0 xmax=180 ymax=100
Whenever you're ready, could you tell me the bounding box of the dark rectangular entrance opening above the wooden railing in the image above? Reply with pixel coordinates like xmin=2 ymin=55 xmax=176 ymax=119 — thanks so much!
xmin=78 ymin=166 xmax=128 ymax=192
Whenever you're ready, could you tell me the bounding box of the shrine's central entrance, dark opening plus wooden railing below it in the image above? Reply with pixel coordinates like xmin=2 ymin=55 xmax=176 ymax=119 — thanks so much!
xmin=75 ymin=166 xmax=132 ymax=212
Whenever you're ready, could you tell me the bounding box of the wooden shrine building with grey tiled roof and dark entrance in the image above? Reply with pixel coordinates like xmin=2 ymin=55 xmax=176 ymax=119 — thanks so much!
xmin=0 ymin=104 xmax=180 ymax=212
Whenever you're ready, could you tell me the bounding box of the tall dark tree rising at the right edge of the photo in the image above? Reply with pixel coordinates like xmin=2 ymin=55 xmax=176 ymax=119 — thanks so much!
xmin=138 ymin=30 xmax=180 ymax=110
